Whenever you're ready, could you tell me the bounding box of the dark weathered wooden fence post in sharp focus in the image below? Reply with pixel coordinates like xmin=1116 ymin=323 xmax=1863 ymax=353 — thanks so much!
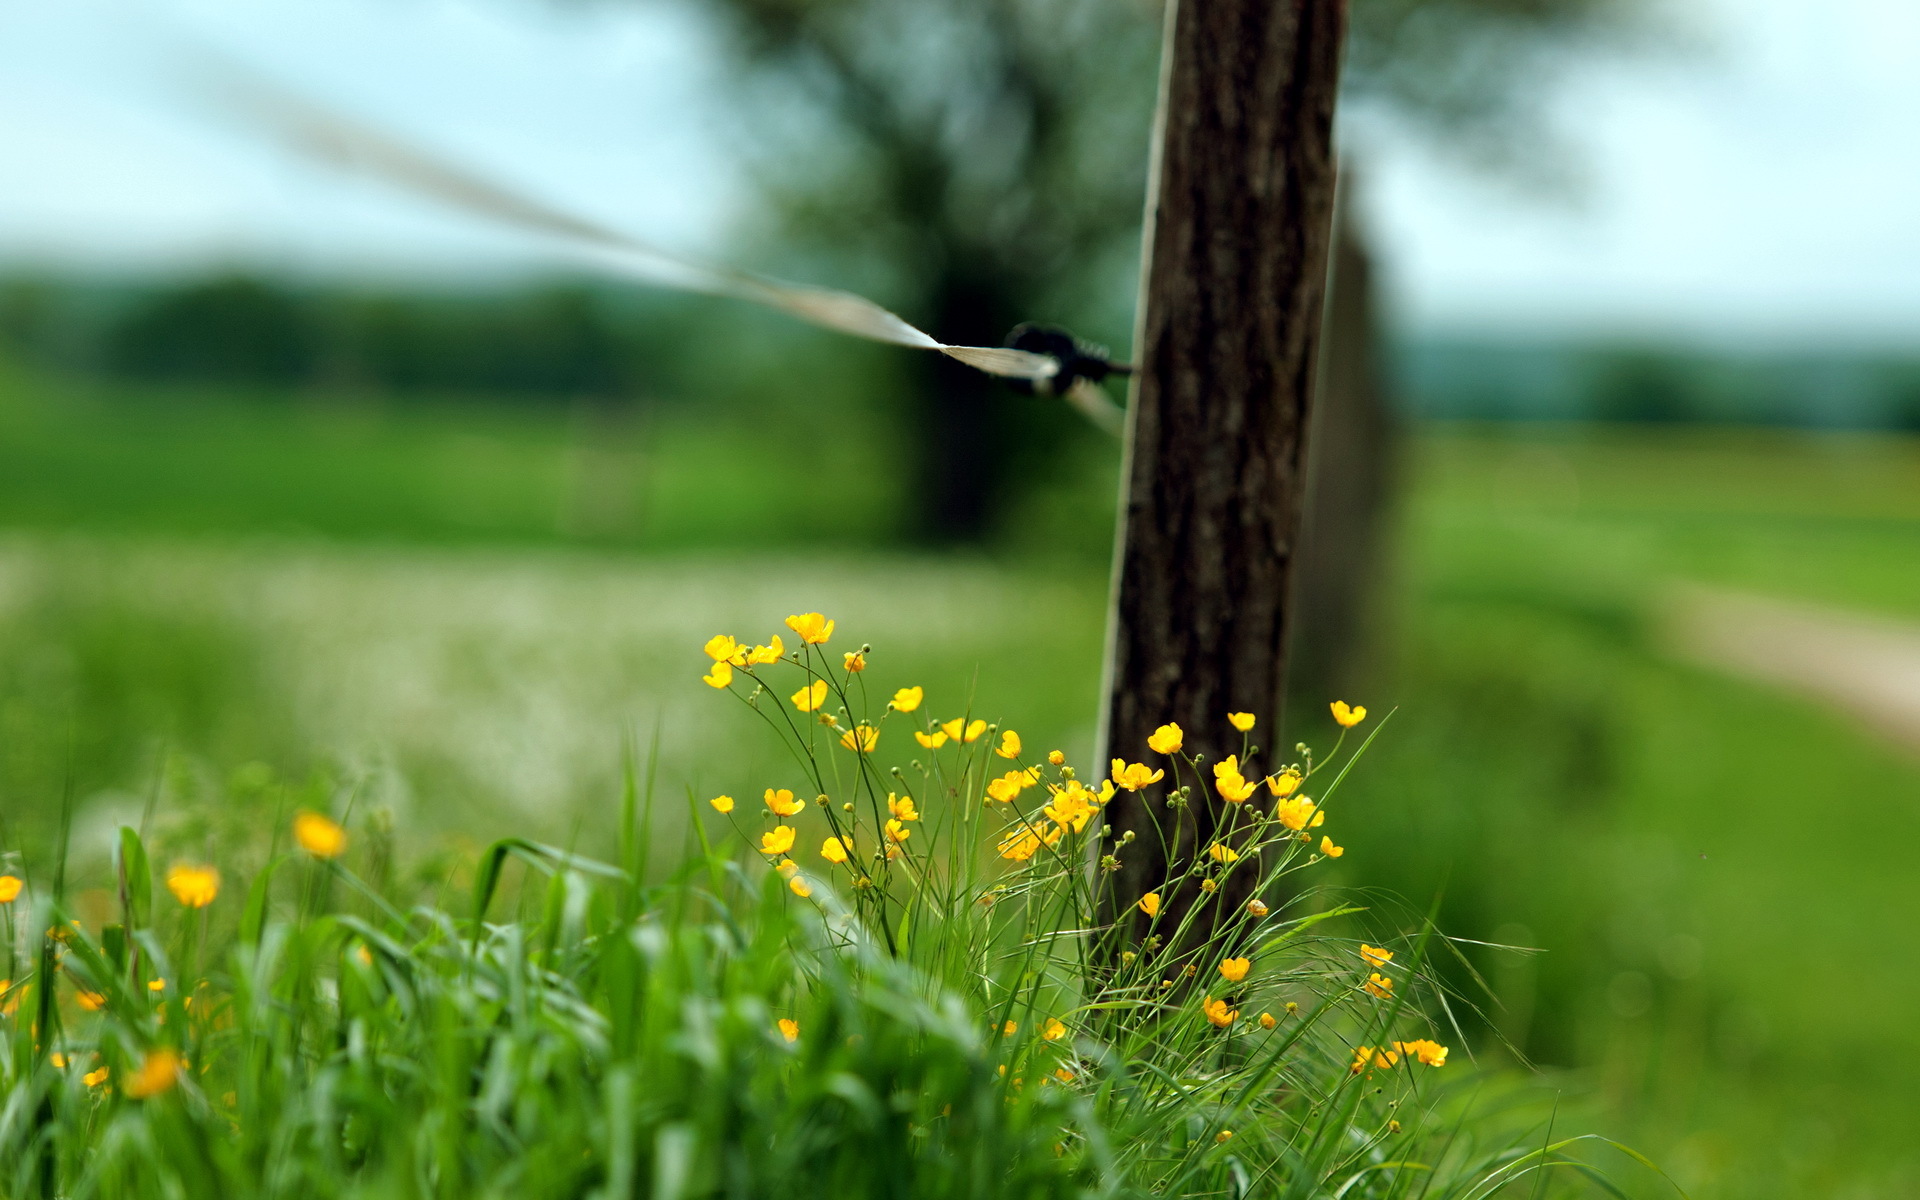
xmin=1102 ymin=0 xmax=1346 ymax=937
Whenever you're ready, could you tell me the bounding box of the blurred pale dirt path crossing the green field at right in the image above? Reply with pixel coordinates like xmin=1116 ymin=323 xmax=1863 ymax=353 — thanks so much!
xmin=1667 ymin=588 xmax=1920 ymax=751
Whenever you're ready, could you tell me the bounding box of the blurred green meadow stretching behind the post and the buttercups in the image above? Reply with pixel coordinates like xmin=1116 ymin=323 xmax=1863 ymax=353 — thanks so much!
xmin=0 ymin=360 xmax=1920 ymax=1196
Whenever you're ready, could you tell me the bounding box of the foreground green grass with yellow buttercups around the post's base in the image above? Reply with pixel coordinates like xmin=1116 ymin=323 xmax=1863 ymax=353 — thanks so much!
xmin=0 ymin=614 xmax=1651 ymax=1200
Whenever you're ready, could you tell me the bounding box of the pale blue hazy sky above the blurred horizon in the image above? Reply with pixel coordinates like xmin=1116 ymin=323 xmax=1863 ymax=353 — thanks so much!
xmin=0 ymin=0 xmax=1920 ymax=348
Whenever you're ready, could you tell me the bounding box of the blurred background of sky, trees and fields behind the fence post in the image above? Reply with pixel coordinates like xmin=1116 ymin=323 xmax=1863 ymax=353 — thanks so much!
xmin=0 ymin=0 xmax=1920 ymax=1196
